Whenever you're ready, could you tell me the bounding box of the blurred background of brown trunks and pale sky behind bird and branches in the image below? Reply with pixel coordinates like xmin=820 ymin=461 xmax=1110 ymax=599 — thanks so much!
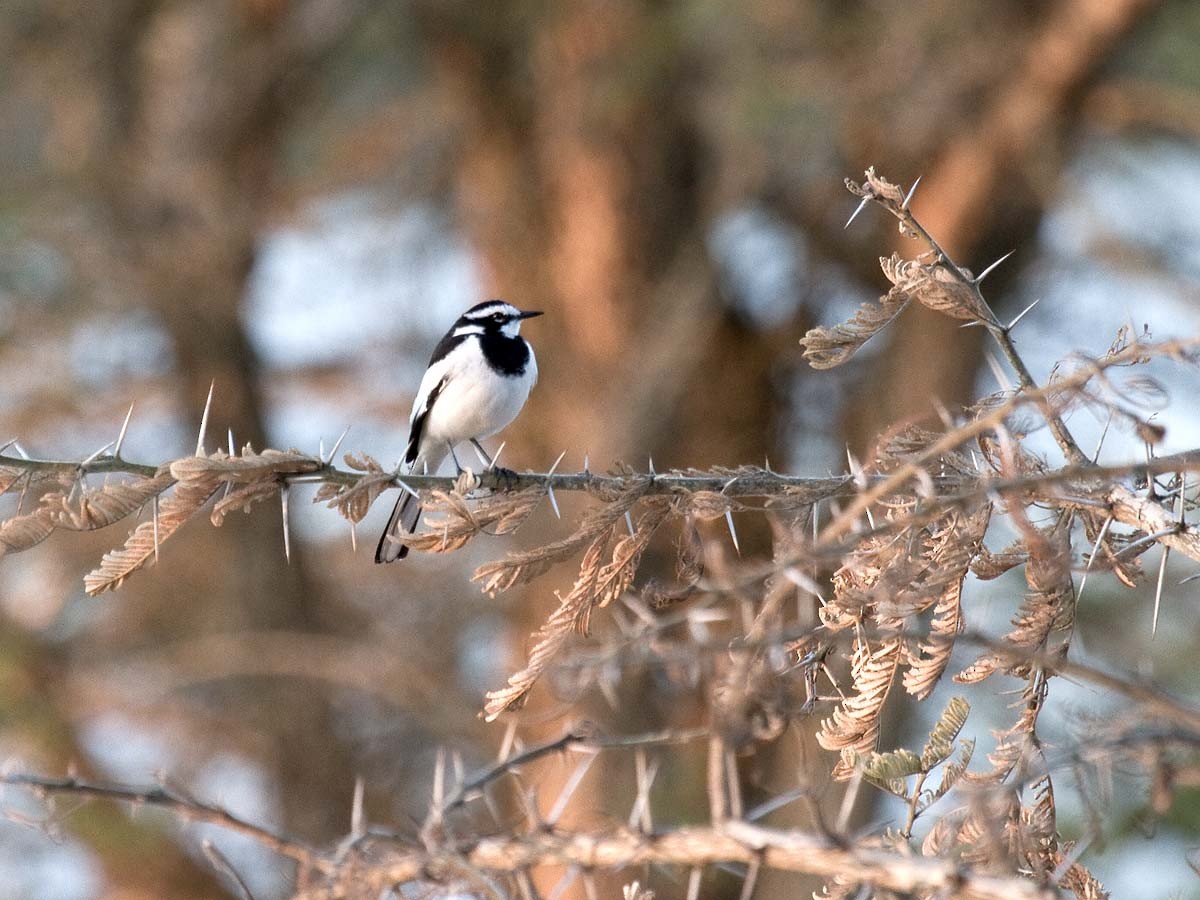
xmin=0 ymin=0 xmax=1200 ymax=900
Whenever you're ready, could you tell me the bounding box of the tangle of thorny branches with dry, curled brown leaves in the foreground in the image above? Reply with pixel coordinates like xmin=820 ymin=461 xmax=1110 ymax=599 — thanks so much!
xmin=0 ymin=170 xmax=1200 ymax=900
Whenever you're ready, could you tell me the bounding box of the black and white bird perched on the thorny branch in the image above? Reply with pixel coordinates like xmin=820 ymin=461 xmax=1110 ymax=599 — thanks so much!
xmin=376 ymin=300 xmax=541 ymax=563
